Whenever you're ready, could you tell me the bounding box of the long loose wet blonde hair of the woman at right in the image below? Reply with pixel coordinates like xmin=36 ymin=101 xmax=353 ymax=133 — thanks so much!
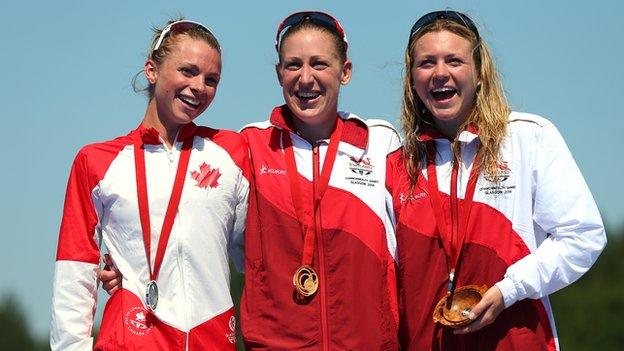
xmin=400 ymin=19 xmax=511 ymax=188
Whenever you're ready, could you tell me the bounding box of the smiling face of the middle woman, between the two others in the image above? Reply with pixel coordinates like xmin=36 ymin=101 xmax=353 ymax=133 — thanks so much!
xmin=276 ymin=28 xmax=351 ymax=139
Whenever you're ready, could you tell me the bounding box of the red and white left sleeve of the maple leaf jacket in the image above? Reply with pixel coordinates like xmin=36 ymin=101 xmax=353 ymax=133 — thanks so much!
xmin=50 ymin=152 xmax=100 ymax=350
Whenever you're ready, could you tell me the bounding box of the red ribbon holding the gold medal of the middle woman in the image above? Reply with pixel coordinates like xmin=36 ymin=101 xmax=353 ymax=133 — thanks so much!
xmin=283 ymin=117 xmax=344 ymax=266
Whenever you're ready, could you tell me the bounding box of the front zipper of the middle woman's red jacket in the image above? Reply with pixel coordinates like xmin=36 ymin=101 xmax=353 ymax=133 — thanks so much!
xmin=312 ymin=145 xmax=329 ymax=351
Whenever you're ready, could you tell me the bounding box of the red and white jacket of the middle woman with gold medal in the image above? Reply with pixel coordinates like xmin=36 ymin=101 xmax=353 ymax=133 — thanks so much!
xmin=241 ymin=106 xmax=400 ymax=350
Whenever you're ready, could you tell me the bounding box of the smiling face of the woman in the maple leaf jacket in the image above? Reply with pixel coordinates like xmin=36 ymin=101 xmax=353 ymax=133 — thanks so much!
xmin=145 ymin=35 xmax=221 ymax=130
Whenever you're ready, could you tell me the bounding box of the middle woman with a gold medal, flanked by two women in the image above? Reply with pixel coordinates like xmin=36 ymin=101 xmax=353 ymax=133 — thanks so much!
xmin=241 ymin=12 xmax=399 ymax=350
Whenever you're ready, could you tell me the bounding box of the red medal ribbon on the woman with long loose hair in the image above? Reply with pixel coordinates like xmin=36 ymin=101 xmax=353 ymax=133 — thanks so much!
xmin=427 ymin=141 xmax=479 ymax=294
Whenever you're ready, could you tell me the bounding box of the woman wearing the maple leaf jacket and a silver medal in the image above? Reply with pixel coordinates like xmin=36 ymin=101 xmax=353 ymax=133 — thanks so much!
xmin=50 ymin=20 xmax=249 ymax=350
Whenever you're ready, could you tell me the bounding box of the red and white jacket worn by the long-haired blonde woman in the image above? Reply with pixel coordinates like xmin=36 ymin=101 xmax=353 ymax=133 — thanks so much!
xmin=388 ymin=112 xmax=606 ymax=351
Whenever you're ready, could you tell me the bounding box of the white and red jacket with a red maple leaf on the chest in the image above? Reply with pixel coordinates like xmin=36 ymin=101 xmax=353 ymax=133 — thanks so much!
xmin=50 ymin=123 xmax=249 ymax=351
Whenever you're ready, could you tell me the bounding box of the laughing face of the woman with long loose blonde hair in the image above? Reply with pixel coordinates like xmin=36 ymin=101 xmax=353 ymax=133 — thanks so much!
xmin=411 ymin=30 xmax=478 ymax=136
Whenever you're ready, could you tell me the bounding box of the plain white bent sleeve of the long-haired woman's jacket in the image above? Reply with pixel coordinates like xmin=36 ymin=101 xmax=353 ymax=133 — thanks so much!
xmin=496 ymin=122 xmax=607 ymax=307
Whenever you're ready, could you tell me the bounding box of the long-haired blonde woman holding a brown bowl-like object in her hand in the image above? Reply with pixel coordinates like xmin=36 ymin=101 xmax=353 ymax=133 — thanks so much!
xmin=388 ymin=11 xmax=606 ymax=350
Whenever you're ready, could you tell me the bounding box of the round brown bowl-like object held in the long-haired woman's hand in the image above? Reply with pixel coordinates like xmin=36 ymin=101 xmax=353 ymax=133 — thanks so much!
xmin=433 ymin=285 xmax=488 ymax=328
